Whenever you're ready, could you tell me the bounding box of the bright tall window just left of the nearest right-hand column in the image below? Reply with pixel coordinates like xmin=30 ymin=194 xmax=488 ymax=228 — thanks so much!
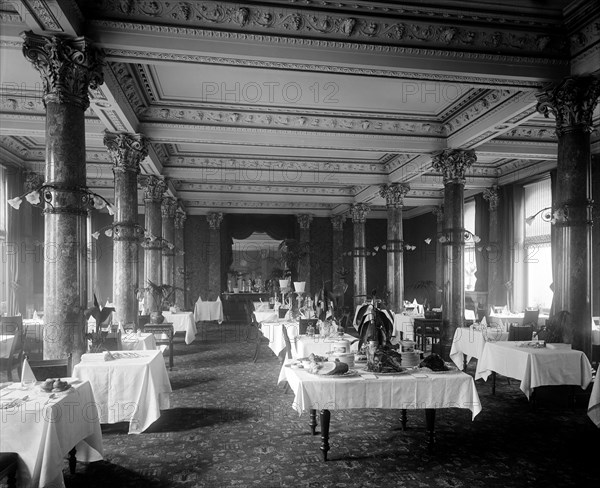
xmin=524 ymin=178 xmax=552 ymax=311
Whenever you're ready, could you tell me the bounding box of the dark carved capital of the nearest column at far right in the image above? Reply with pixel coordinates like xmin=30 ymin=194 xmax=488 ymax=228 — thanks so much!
xmin=536 ymin=75 xmax=600 ymax=134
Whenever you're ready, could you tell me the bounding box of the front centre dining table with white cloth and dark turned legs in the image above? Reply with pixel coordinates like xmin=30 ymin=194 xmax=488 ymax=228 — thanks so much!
xmin=280 ymin=364 xmax=481 ymax=461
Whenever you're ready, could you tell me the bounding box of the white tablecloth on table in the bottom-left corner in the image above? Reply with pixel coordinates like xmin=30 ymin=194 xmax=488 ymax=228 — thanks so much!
xmin=0 ymin=378 xmax=103 ymax=488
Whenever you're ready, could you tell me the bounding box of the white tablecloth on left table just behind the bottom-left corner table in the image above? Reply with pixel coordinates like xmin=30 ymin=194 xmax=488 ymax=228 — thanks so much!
xmin=73 ymin=351 xmax=172 ymax=434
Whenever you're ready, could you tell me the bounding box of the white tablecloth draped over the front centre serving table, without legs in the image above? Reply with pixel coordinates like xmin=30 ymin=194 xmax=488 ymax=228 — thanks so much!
xmin=285 ymin=367 xmax=481 ymax=418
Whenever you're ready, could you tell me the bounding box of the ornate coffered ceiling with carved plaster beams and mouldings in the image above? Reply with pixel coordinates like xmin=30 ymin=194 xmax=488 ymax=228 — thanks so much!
xmin=0 ymin=0 xmax=600 ymax=216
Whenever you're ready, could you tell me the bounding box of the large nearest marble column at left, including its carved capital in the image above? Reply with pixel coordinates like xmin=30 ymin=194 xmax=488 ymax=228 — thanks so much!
xmin=22 ymin=32 xmax=103 ymax=363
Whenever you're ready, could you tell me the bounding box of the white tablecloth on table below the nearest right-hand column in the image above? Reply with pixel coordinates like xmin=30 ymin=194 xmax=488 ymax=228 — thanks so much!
xmin=475 ymin=342 xmax=592 ymax=398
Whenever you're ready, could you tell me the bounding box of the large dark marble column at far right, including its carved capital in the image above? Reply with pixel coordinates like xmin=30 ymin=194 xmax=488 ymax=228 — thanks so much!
xmin=537 ymin=75 xmax=600 ymax=358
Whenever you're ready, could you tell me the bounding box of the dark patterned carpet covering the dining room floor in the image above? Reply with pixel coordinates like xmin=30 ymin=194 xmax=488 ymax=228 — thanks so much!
xmin=4 ymin=324 xmax=600 ymax=488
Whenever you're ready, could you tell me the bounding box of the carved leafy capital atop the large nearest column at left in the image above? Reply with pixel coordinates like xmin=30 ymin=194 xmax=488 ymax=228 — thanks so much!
xmin=21 ymin=31 xmax=104 ymax=110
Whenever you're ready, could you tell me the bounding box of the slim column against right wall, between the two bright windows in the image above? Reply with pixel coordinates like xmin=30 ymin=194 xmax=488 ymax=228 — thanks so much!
xmin=483 ymin=185 xmax=505 ymax=310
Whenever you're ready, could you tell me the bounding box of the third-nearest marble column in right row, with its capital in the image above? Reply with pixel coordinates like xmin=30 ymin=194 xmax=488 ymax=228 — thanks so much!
xmin=379 ymin=183 xmax=410 ymax=312
